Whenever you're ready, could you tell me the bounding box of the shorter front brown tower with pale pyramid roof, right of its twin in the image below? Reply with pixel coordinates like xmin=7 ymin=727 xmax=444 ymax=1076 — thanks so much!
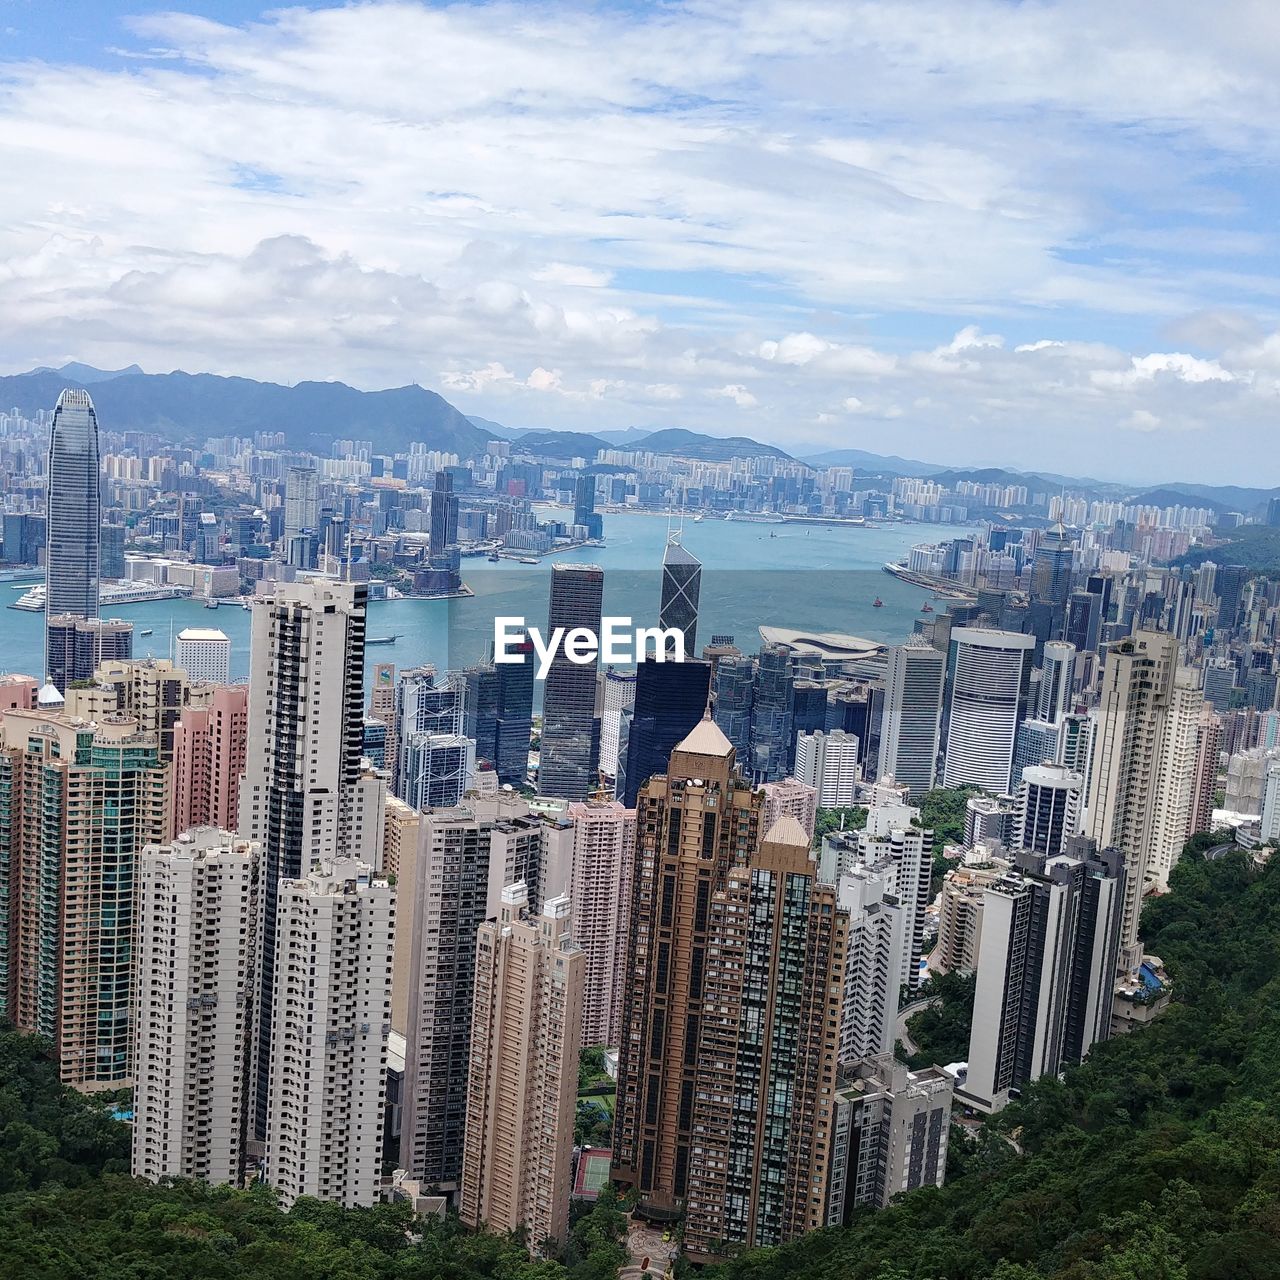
xmin=680 ymin=814 xmax=847 ymax=1261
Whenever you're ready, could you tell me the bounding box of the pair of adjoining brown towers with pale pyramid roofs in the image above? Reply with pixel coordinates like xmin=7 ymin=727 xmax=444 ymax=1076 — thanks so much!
xmin=613 ymin=719 xmax=847 ymax=1261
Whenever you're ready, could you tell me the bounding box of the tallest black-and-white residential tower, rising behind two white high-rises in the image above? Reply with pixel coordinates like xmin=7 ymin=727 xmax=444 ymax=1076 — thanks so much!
xmin=237 ymin=581 xmax=380 ymax=1138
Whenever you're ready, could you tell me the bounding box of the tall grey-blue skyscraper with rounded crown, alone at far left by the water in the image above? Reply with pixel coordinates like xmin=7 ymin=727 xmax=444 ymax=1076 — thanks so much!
xmin=45 ymin=389 xmax=102 ymax=669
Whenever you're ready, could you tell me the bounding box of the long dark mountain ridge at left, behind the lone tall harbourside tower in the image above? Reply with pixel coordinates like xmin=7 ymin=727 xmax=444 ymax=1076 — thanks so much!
xmin=0 ymin=371 xmax=493 ymax=457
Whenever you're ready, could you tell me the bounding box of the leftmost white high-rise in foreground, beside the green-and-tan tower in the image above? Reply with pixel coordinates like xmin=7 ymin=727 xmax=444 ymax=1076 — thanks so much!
xmin=133 ymin=827 xmax=260 ymax=1185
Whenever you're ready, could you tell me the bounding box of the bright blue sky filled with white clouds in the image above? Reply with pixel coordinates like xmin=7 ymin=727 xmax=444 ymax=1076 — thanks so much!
xmin=0 ymin=0 xmax=1280 ymax=486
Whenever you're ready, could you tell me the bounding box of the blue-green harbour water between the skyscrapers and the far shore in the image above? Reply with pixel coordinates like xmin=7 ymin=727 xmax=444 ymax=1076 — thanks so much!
xmin=0 ymin=513 xmax=965 ymax=680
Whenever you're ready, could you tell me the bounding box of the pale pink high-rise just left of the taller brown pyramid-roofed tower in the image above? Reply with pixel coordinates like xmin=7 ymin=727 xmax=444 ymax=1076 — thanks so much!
xmin=568 ymin=800 xmax=636 ymax=1047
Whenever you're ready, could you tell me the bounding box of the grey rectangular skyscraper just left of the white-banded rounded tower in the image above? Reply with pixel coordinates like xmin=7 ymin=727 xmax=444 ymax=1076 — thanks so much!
xmin=876 ymin=637 xmax=946 ymax=799
